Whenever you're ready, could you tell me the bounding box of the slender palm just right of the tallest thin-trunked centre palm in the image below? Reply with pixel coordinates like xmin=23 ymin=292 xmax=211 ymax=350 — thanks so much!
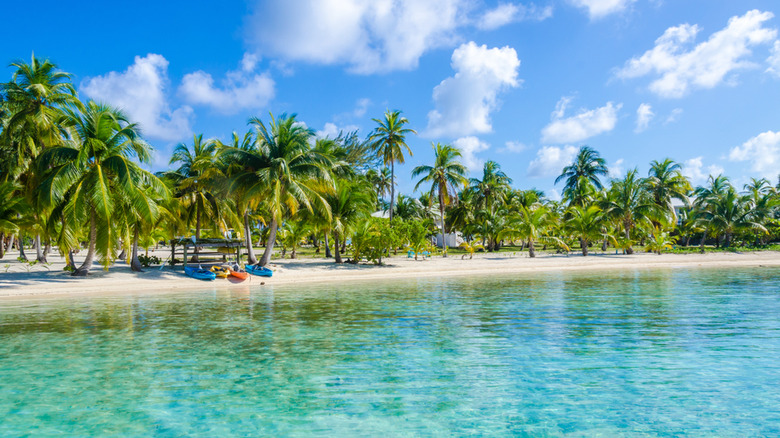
xmin=412 ymin=143 xmax=468 ymax=257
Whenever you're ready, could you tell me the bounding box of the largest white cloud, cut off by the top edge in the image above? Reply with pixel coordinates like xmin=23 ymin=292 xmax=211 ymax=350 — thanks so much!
xmin=246 ymin=0 xmax=473 ymax=74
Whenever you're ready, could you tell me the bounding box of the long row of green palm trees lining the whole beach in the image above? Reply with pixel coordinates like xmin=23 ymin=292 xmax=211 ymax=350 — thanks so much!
xmin=0 ymin=56 xmax=780 ymax=275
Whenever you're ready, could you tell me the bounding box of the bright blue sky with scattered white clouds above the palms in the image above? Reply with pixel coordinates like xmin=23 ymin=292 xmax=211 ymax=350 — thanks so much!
xmin=0 ymin=0 xmax=780 ymax=197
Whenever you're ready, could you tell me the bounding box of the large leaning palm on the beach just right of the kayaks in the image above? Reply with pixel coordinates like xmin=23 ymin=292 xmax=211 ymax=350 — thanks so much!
xmin=250 ymin=114 xmax=333 ymax=266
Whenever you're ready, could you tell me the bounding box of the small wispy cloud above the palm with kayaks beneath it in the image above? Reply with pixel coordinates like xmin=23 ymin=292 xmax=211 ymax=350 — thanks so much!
xmin=179 ymin=54 xmax=275 ymax=114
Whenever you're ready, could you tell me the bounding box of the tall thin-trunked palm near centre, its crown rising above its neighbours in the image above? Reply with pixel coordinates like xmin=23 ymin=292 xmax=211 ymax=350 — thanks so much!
xmin=368 ymin=110 xmax=417 ymax=222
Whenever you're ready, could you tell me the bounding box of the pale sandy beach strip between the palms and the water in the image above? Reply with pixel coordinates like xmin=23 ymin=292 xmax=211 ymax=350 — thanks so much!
xmin=0 ymin=251 xmax=780 ymax=298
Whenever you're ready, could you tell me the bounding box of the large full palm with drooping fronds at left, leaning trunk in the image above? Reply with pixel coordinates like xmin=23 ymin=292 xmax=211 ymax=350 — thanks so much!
xmin=38 ymin=102 xmax=157 ymax=276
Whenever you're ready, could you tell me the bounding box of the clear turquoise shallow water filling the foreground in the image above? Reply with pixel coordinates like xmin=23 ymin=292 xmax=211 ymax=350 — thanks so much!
xmin=0 ymin=268 xmax=780 ymax=437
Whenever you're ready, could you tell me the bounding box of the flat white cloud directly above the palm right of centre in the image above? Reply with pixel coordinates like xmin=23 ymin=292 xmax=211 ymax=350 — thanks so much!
xmin=542 ymin=97 xmax=623 ymax=143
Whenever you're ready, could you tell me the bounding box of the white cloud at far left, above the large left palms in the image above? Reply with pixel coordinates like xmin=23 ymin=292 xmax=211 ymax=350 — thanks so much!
xmin=79 ymin=53 xmax=193 ymax=141
